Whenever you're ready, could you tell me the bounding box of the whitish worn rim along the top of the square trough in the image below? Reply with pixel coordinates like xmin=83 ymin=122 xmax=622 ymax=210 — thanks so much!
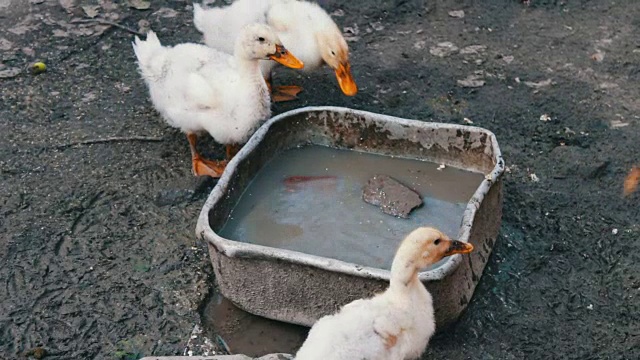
xmin=196 ymin=106 xmax=505 ymax=282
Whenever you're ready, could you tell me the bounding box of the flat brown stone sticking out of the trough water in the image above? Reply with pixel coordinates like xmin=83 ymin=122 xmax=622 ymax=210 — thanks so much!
xmin=362 ymin=175 xmax=422 ymax=219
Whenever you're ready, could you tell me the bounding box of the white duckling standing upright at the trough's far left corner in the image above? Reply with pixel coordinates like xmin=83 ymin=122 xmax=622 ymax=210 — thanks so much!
xmin=133 ymin=24 xmax=304 ymax=178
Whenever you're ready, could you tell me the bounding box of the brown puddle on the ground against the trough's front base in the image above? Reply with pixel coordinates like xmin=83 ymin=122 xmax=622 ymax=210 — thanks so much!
xmin=202 ymin=292 xmax=309 ymax=357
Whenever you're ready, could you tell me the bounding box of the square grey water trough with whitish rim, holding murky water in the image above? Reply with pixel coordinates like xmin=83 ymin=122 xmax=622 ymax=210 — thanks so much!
xmin=197 ymin=107 xmax=504 ymax=328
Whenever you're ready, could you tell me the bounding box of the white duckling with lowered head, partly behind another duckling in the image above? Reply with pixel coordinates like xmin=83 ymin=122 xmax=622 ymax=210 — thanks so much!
xmin=193 ymin=0 xmax=358 ymax=101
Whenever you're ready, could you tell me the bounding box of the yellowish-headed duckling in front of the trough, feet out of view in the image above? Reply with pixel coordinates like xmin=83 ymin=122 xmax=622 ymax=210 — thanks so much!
xmin=295 ymin=227 xmax=473 ymax=360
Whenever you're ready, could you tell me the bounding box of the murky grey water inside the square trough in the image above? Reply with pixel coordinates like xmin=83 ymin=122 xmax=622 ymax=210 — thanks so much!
xmin=221 ymin=146 xmax=483 ymax=269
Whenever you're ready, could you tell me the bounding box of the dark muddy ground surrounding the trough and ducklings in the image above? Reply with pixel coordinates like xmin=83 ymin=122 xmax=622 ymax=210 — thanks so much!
xmin=0 ymin=0 xmax=640 ymax=359
